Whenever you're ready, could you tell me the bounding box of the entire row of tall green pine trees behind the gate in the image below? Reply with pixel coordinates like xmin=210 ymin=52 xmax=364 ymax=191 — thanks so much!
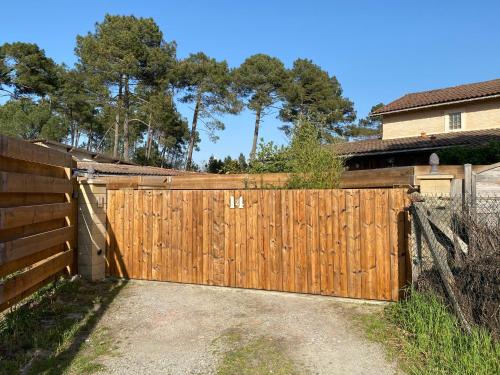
xmin=0 ymin=14 xmax=360 ymax=169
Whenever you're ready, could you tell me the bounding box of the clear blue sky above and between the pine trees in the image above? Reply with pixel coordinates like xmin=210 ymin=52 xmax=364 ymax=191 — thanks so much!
xmin=0 ymin=0 xmax=500 ymax=162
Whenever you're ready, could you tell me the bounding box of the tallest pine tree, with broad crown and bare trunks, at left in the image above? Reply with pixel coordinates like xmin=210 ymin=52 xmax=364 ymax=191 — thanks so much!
xmin=75 ymin=14 xmax=183 ymax=160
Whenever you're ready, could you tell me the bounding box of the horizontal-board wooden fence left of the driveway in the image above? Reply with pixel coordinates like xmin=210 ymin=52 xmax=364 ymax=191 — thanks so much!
xmin=0 ymin=136 xmax=76 ymax=311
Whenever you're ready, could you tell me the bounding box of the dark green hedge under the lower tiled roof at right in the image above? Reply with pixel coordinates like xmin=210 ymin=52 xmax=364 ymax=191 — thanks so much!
xmin=437 ymin=141 xmax=500 ymax=165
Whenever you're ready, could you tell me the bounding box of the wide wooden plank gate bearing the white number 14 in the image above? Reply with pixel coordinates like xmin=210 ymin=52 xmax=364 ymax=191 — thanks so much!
xmin=107 ymin=189 xmax=408 ymax=300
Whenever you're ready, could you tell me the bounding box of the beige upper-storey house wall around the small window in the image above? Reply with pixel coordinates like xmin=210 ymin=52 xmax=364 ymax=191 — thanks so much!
xmin=382 ymin=98 xmax=500 ymax=139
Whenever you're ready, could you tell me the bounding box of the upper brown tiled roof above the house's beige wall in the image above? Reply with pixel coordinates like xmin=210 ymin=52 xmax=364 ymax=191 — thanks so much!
xmin=372 ymin=78 xmax=500 ymax=115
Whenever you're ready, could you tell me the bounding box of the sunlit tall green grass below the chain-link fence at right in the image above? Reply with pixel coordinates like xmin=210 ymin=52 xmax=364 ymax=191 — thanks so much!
xmin=362 ymin=291 xmax=500 ymax=375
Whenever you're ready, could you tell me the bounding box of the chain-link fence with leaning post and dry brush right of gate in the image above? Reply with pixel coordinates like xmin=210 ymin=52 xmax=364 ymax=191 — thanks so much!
xmin=411 ymin=194 xmax=500 ymax=338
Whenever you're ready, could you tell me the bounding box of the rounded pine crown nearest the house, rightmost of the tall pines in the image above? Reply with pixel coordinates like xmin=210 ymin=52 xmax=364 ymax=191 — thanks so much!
xmin=280 ymin=59 xmax=356 ymax=140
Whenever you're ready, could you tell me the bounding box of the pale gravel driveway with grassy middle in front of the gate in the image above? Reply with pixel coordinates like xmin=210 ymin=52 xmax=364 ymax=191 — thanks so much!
xmin=93 ymin=281 xmax=396 ymax=375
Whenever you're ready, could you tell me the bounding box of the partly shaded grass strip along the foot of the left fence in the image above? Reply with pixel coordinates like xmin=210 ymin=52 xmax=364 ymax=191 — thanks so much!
xmin=0 ymin=279 xmax=121 ymax=375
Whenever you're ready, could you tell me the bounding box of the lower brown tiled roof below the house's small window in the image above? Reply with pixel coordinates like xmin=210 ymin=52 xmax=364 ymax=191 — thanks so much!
xmin=333 ymin=129 xmax=500 ymax=156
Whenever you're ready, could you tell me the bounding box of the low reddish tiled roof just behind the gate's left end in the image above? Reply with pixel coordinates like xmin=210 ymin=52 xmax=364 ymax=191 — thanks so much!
xmin=77 ymin=161 xmax=196 ymax=176
